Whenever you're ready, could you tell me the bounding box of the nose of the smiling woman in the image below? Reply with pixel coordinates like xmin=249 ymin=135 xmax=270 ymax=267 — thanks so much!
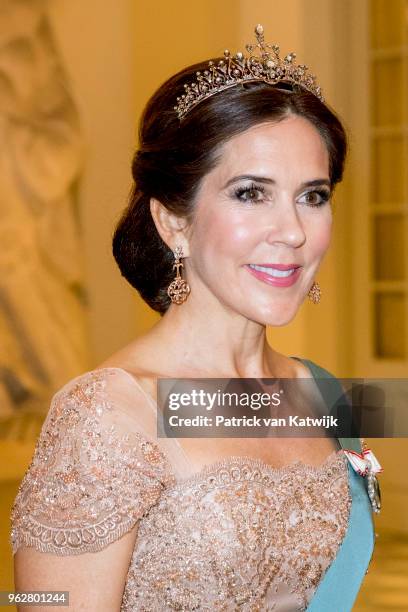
xmin=266 ymin=199 xmax=306 ymax=247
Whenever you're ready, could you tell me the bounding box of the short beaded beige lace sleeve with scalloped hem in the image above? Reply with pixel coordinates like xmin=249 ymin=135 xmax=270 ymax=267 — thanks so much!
xmin=11 ymin=369 xmax=172 ymax=555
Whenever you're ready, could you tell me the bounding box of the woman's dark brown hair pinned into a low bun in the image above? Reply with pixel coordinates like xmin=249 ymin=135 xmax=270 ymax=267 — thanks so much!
xmin=113 ymin=60 xmax=346 ymax=314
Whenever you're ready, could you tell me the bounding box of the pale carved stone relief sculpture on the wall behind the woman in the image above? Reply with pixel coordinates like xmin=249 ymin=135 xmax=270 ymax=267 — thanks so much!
xmin=0 ymin=0 xmax=88 ymax=417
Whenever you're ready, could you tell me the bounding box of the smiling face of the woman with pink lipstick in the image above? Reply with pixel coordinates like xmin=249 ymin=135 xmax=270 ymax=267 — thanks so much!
xmin=185 ymin=115 xmax=332 ymax=326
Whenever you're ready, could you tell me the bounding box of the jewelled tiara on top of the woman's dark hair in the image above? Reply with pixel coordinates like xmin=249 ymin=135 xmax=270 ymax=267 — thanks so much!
xmin=174 ymin=24 xmax=324 ymax=121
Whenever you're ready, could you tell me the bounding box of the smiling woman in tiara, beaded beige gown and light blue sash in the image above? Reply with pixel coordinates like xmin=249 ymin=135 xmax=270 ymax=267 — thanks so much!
xmin=12 ymin=26 xmax=380 ymax=612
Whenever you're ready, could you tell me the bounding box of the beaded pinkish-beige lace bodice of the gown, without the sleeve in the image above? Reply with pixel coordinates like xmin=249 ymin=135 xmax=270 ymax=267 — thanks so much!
xmin=122 ymin=452 xmax=350 ymax=612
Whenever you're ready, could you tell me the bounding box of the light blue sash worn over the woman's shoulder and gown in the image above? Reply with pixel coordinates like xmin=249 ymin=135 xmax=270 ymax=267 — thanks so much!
xmin=295 ymin=357 xmax=374 ymax=612
